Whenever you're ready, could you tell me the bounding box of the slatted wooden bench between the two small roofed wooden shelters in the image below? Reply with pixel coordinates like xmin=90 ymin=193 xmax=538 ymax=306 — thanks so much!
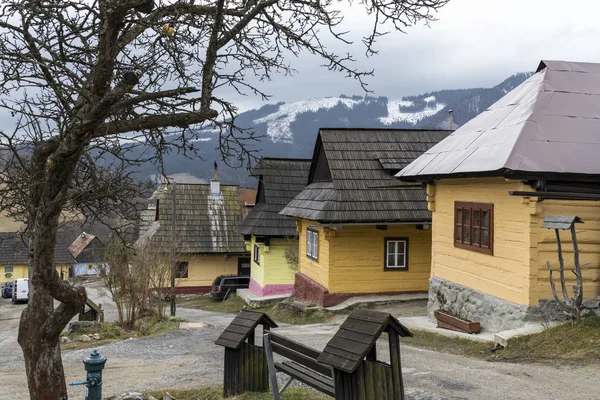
xmin=264 ymin=332 xmax=335 ymax=400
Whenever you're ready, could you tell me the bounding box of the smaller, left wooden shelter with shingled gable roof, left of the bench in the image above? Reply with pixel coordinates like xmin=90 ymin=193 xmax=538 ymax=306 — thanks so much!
xmin=215 ymin=310 xmax=277 ymax=397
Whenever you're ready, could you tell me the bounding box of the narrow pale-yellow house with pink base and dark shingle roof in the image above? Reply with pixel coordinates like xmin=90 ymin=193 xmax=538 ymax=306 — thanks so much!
xmin=237 ymin=157 xmax=311 ymax=296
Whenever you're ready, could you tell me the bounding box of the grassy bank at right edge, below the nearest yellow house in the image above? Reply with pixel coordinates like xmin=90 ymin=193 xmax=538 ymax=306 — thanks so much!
xmin=493 ymin=317 xmax=600 ymax=364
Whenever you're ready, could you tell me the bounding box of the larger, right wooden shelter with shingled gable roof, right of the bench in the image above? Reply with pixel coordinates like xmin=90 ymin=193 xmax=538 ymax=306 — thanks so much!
xmin=317 ymin=309 xmax=412 ymax=400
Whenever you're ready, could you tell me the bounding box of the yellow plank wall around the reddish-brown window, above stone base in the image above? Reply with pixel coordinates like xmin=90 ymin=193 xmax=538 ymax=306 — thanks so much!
xmin=431 ymin=178 xmax=530 ymax=304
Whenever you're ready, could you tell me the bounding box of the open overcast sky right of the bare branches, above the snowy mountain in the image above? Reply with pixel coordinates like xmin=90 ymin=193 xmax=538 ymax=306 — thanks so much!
xmin=226 ymin=0 xmax=600 ymax=110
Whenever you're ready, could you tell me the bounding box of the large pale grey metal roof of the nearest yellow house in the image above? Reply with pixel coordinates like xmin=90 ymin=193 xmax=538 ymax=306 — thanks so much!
xmin=397 ymin=61 xmax=600 ymax=180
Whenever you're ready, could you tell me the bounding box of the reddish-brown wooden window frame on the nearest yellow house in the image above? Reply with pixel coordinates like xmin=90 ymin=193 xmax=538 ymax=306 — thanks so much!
xmin=453 ymin=201 xmax=494 ymax=255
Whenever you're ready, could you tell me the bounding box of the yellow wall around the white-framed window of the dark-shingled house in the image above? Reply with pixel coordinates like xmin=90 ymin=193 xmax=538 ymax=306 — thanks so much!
xmin=329 ymin=225 xmax=431 ymax=293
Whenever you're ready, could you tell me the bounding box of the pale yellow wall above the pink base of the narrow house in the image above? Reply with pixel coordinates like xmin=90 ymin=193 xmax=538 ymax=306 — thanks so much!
xmin=250 ymin=236 xmax=298 ymax=287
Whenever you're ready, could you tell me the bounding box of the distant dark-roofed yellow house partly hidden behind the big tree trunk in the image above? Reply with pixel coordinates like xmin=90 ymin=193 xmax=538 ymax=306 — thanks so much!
xmin=0 ymin=230 xmax=75 ymax=282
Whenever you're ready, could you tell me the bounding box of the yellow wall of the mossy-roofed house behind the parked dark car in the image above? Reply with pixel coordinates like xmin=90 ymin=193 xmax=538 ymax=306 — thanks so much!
xmin=177 ymin=254 xmax=238 ymax=286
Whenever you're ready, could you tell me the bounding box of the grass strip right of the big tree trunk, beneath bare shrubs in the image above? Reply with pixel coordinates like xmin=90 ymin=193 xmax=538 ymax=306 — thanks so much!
xmin=60 ymin=317 xmax=187 ymax=350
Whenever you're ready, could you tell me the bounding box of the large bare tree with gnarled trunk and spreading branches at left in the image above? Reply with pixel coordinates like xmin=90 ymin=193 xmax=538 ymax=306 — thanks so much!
xmin=0 ymin=0 xmax=448 ymax=400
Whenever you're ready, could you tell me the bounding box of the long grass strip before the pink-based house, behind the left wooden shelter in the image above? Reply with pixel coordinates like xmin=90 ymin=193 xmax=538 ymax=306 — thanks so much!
xmin=177 ymin=295 xmax=335 ymax=325
